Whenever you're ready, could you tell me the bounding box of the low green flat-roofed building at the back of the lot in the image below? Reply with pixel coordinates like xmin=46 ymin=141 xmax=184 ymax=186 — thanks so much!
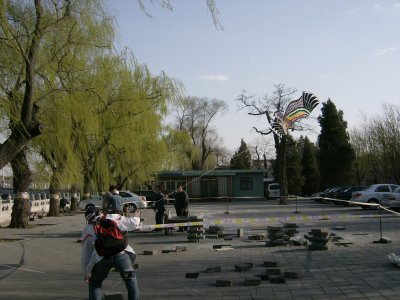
xmin=156 ymin=169 xmax=266 ymax=199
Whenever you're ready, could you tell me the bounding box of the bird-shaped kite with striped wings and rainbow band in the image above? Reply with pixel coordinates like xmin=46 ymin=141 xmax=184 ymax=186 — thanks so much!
xmin=271 ymin=92 xmax=319 ymax=138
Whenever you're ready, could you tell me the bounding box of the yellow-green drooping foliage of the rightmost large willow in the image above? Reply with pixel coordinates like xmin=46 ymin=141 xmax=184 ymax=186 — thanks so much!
xmin=98 ymin=53 xmax=181 ymax=188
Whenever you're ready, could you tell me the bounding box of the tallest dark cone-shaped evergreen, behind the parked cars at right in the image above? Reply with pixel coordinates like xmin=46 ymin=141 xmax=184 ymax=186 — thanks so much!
xmin=318 ymin=99 xmax=355 ymax=188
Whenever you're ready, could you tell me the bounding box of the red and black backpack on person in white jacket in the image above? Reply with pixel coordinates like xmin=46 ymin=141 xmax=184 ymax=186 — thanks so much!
xmin=94 ymin=216 xmax=128 ymax=256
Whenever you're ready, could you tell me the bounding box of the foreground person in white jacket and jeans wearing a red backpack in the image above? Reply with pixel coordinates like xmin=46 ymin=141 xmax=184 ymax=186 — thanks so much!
xmin=81 ymin=198 xmax=140 ymax=300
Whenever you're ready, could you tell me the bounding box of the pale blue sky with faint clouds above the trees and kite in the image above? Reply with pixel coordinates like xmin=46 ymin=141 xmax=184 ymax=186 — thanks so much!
xmin=107 ymin=0 xmax=400 ymax=151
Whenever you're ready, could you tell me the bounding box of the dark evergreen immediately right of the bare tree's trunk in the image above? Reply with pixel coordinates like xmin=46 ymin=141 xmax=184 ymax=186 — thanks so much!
xmin=286 ymin=135 xmax=304 ymax=195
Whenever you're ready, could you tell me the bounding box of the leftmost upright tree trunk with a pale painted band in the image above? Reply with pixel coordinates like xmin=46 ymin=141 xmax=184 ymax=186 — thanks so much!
xmin=10 ymin=149 xmax=31 ymax=228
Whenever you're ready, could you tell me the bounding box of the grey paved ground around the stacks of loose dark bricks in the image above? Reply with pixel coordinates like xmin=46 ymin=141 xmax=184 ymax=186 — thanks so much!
xmin=0 ymin=200 xmax=400 ymax=299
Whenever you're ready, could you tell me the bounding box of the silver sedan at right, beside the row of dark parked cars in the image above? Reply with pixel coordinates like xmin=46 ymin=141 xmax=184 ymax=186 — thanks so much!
xmin=350 ymin=183 xmax=399 ymax=209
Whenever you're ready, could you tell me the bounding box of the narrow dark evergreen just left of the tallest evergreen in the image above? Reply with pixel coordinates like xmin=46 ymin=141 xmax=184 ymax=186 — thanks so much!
xmin=301 ymin=137 xmax=320 ymax=196
